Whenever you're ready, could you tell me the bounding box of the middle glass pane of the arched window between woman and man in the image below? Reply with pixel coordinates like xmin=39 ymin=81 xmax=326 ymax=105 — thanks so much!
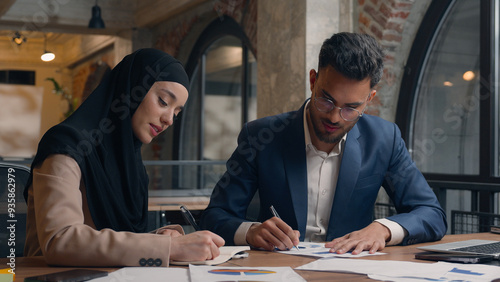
xmin=203 ymin=36 xmax=243 ymax=160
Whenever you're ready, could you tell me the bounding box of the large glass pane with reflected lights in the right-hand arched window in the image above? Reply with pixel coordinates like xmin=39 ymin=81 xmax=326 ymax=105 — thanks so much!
xmin=411 ymin=1 xmax=481 ymax=175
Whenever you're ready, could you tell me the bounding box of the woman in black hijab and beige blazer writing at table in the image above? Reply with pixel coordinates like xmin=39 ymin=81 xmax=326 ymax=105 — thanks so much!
xmin=24 ymin=49 xmax=224 ymax=266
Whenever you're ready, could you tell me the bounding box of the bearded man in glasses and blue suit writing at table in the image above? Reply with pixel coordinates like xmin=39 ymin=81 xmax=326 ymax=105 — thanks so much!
xmin=201 ymin=33 xmax=447 ymax=254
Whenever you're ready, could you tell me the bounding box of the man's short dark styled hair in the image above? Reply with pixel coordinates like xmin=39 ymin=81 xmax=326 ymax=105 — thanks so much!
xmin=318 ymin=32 xmax=384 ymax=88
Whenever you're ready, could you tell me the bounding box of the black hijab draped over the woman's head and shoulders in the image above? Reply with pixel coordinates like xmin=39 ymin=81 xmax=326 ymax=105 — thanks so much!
xmin=24 ymin=49 xmax=189 ymax=232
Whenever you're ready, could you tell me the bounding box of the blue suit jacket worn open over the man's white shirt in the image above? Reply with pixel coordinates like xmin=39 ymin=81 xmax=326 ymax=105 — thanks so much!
xmin=201 ymin=101 xmax=447 ymax=245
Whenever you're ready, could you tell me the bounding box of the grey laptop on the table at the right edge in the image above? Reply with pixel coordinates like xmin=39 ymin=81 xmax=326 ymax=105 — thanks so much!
xmin=417 ymin=240 xmax=500 ymax=259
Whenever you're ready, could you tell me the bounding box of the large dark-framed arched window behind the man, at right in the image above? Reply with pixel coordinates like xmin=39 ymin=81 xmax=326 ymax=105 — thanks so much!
xmin=396 ymin=0 xmax=500 ymax=219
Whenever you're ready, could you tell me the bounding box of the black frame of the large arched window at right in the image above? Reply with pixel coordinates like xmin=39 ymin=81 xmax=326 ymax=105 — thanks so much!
xmin=396 ymin=0 xmax=500 ymax=212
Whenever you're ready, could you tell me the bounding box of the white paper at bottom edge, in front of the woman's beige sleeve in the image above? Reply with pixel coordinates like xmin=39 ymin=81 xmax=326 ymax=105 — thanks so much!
xmin=90 ymin=267 xmax=191 ymax=282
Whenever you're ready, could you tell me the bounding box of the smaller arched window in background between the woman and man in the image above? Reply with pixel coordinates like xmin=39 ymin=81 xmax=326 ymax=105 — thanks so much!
xmin=173 ymin=17 xmax=257 ymax=191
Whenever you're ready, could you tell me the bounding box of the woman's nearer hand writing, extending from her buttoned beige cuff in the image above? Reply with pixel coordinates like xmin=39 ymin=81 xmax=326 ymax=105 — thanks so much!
xmin=170 ymin=231 xmax=225 ymax=261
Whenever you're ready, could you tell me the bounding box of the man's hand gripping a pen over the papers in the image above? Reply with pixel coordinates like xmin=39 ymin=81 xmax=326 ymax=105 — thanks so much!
xmin=246 ymin=216 xmax=300 ymax=251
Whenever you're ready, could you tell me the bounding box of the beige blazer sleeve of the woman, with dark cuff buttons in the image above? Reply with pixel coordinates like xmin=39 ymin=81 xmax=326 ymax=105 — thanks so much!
xmin=32 ymin=155 xmax=175 ymax=266
